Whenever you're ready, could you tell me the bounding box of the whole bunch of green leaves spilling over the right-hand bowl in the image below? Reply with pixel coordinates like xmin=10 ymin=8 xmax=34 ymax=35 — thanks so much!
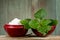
xmin=20 ymin=8 xmax=57 ymax=35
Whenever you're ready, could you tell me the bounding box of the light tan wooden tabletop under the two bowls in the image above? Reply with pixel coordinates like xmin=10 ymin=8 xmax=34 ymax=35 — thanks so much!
xmin=0 ymin=35 xmax=60 ymax=40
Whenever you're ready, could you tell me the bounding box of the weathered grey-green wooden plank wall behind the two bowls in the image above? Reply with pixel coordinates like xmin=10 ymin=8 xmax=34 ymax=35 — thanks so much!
xmin=0 ymin=0 xmax=60 ymax=35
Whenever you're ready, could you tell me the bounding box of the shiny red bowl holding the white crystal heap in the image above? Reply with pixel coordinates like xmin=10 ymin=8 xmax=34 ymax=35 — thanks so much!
xmin=4 ymin=24 xmax=27 ymax=37
